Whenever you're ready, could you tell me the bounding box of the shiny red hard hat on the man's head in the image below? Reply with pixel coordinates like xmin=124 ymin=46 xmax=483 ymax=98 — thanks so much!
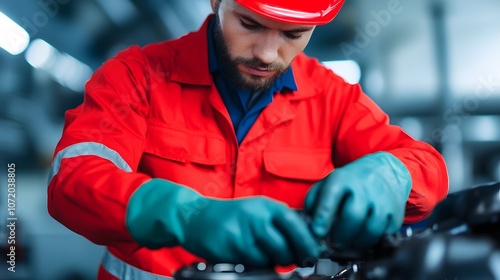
xmin=235 ymin=0 xmax=344 ymax=25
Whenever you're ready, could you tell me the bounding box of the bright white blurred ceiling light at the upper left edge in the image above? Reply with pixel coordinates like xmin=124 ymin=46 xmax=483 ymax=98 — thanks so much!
xmin=0 ymin=12 xmax=30 ymax=55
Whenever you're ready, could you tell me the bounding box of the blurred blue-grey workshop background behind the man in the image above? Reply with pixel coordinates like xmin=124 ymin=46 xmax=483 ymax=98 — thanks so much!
xmin=0 ymin=0 xmax=500 ymax=280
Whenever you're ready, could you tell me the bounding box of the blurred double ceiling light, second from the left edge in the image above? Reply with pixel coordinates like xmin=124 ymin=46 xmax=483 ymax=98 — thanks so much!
xmin=26 ymin=39 xmax=92 ymax=92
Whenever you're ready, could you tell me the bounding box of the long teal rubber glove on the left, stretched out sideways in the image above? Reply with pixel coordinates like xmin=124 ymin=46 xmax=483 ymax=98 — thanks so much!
xmin=126 ymin=179 xmax=319 ymax=267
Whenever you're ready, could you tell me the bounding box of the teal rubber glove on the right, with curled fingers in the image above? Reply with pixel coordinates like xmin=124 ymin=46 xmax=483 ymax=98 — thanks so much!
xmin=305 ymin=152 xmax=412 ymax=249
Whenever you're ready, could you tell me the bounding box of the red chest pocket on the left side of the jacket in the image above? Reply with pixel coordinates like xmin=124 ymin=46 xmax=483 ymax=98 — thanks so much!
xmin=140 ymin=121 xmax=231 ymax=197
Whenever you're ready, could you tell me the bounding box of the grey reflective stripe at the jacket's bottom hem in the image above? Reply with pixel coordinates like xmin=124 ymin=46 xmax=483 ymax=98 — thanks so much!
xmin=102 ymin=250 xmax=173 ymax=280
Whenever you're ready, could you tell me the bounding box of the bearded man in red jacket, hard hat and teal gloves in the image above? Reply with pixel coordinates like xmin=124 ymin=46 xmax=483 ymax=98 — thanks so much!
xmin=48 ymin=0 xmax=448 ymax=279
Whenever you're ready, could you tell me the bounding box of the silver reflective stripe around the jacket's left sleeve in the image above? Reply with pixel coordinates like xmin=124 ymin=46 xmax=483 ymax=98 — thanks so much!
xmin=47 ymin=142 xmax=132 ymax=183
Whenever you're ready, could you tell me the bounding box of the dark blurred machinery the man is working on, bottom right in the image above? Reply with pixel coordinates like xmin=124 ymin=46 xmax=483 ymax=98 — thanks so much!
xmin=174 ymin=183 xmax=500 ymax=280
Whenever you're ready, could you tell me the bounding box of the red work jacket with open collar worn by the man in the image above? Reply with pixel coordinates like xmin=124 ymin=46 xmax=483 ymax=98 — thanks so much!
xmin=48 ymin=16 xmax=448 ymax=279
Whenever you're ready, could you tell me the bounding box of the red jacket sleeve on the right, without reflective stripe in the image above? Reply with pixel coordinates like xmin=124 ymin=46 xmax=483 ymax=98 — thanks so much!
xmin=333 ymin=82 xmax=448 ymax=223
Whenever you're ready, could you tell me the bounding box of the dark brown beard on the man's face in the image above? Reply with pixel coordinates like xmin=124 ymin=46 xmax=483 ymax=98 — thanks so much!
xmin=214 ymin=15 xmax=290 ymax=92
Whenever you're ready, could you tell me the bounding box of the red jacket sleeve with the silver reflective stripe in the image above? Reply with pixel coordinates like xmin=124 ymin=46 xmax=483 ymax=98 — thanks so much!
xmin=47 ymin=47 xmax=156 ymax=249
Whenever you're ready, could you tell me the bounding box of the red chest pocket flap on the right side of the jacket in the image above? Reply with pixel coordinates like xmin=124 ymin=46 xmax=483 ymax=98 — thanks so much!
xmin=263 ymin=149 xmax=334 ymax=181
